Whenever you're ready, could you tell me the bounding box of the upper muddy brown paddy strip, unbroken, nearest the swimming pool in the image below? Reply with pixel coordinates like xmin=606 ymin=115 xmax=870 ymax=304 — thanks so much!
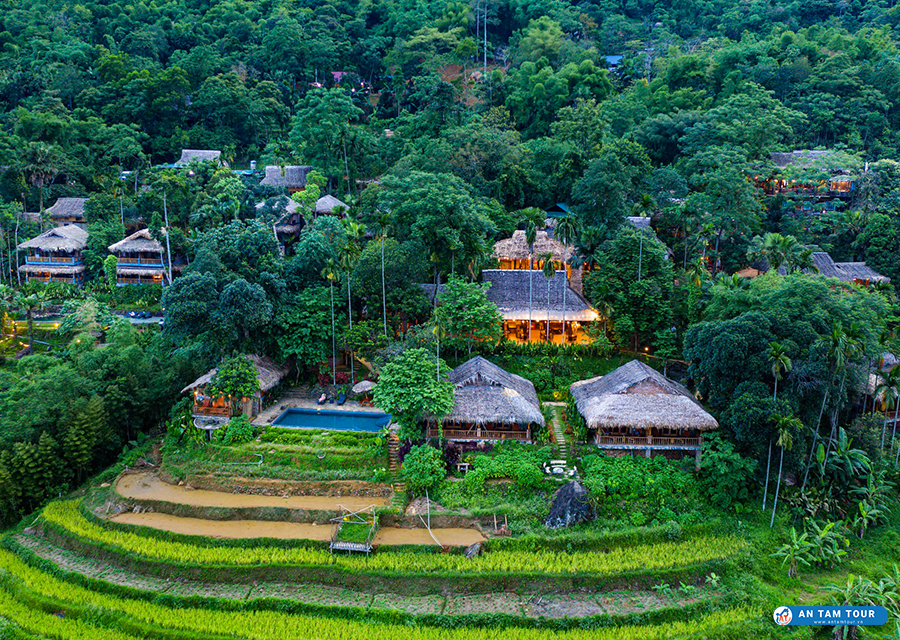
xmin=116 ymin=473 xmax=390 ymax=511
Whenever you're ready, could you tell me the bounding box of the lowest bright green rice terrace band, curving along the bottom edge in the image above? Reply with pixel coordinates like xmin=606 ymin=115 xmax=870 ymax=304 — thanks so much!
xmin=0 ymin=552 xmax=772 ymax=640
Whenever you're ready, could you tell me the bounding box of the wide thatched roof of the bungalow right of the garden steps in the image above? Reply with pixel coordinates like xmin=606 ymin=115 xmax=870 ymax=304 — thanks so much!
xmin=569 ymin=360 xmax=719 ymax=431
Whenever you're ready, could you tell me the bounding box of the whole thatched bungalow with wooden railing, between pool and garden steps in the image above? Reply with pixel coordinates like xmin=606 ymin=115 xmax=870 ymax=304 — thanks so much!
xmin=428 ymin=356 xmax=545 ymax=442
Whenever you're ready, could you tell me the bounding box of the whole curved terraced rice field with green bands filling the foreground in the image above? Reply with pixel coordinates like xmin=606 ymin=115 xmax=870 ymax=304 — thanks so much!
xmin=0 ymin=476 xmax=768 ymax=640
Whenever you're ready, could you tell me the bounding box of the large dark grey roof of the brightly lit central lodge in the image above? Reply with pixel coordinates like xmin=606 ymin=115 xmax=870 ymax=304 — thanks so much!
xmin=482 ymin=269 xmax=600 ymax=322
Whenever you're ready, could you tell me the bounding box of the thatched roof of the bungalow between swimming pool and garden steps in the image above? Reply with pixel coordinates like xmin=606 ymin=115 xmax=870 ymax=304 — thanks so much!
xmin=441 ymin=356 xmax=544 ymax=425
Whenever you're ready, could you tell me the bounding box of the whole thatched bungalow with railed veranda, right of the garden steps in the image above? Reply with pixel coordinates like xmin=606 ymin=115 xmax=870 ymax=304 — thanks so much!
xmin=569 ymin=360 xmax=719 ymax=463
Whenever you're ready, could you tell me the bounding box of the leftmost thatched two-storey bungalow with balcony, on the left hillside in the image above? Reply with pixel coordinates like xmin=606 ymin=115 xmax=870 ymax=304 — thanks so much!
xmin=18 ymin=224 xmax=88 ymax=285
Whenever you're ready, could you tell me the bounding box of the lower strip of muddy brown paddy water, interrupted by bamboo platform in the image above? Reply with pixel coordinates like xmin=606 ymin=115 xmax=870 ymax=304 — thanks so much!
xmin=112 ymin=513 xmax=484 ymax=546
